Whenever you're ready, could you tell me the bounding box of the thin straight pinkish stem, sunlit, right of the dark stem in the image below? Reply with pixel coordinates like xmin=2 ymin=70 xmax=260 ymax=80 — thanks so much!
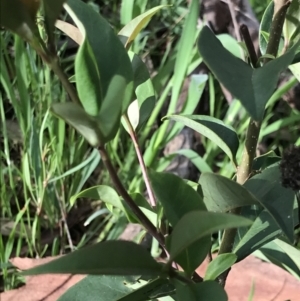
xmin=123 ymin=114 xmax=156 ymax=207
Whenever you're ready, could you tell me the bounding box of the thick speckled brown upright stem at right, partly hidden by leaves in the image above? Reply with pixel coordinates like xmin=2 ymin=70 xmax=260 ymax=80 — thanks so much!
xmin=218 ymin=0 xmax=289 ymax=286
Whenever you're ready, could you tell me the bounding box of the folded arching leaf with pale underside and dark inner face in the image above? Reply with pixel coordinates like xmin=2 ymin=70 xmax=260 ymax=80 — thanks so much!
xmin=165 ymin=115 xmax=239 ymax=163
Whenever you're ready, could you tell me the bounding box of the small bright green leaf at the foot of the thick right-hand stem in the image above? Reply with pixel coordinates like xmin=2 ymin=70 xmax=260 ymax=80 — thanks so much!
xmin=204 ymin=253 xmax=237 ymax=281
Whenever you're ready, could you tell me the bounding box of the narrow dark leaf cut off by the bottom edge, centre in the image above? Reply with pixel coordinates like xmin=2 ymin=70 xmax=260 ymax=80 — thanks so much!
xmin=117 ymin=278 xmax=175 ymax=301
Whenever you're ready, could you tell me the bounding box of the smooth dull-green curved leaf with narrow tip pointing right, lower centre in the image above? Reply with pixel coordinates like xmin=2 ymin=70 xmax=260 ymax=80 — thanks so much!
xmin=169 ymin=211 xmax=252 ymax=262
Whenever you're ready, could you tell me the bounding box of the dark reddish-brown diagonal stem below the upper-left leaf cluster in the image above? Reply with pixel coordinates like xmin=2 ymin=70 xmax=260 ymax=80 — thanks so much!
xmin=98 ymin=146 xmax=165 ymax=247
